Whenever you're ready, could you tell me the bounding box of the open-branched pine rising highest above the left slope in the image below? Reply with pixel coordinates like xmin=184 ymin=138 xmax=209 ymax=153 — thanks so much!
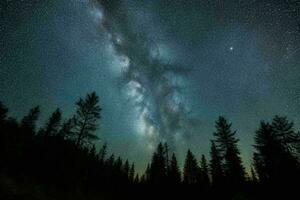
xmin=74 ymin=92 xmax=102 ymax=146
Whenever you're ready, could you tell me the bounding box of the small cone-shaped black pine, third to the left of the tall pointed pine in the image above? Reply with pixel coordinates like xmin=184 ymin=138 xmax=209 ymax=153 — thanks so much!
xmin=183 ymin=150 xmax=200 ymax=184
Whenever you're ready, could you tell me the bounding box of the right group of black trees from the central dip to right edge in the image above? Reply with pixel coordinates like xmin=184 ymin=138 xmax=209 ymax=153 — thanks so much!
xmin=140 ymin=116 xmax=300 ymax=199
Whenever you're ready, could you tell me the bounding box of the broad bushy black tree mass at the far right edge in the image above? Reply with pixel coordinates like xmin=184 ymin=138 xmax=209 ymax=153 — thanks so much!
xmin=253 ymin=116 xmax=299 ymax=185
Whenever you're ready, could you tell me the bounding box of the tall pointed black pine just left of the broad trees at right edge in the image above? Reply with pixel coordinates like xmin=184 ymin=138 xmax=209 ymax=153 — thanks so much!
xmin=214 ymin=117 xmax=245 ymax=186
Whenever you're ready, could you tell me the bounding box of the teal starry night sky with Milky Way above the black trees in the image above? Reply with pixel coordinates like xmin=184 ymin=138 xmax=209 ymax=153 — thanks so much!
xmin=0 ymin=0 xmax=300 ymax=171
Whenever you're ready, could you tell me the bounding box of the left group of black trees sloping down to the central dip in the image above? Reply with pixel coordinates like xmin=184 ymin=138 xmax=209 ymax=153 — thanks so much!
xmin=0 ymin=92 xmax=135 ymax=199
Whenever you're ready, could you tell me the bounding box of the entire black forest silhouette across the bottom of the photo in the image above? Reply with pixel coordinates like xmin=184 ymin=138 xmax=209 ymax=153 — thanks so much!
xmin=0 ymin=92 xmax=300 ymax=199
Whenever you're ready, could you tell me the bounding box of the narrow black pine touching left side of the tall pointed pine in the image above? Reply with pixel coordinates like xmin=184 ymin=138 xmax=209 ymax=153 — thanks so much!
xmin=210 ymin=141 xmax=224 ymax=187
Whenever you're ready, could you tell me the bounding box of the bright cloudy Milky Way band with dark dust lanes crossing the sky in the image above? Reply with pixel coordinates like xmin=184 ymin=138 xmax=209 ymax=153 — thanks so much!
xmin=94 ymin=0 xmax=195 ymax=149
